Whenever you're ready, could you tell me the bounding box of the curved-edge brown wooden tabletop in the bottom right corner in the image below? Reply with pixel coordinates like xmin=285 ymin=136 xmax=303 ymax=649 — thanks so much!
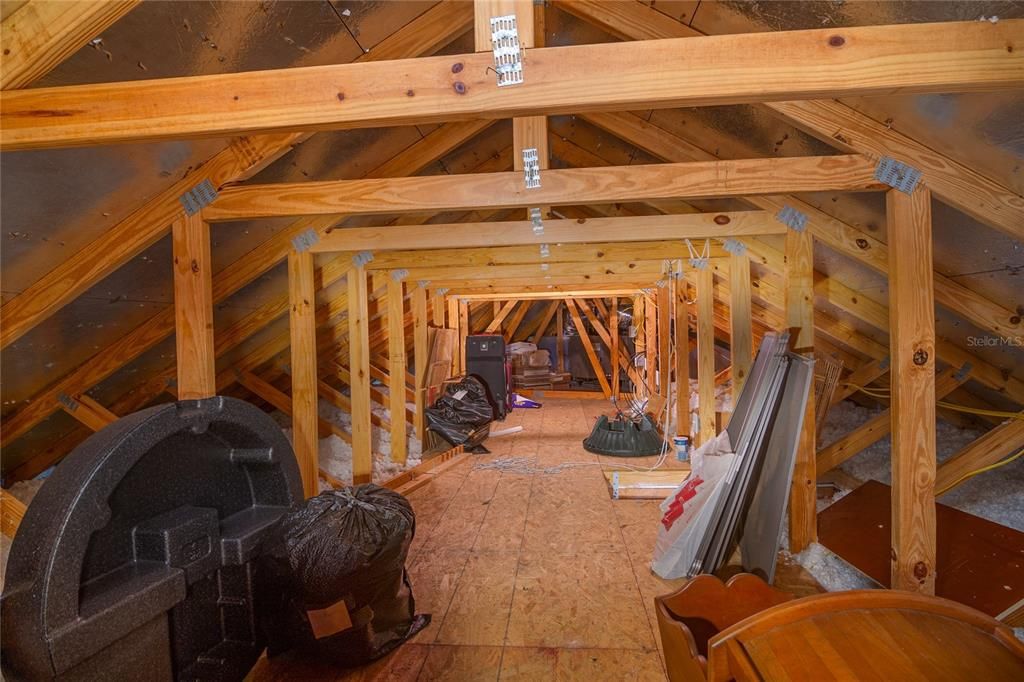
xmin=708 ymin=590 xmax=1024 ymax=682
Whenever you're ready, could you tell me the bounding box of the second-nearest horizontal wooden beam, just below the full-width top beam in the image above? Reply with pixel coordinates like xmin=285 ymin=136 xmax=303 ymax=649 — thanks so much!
xmin=203 ymin=155 xmax=887 ymax=222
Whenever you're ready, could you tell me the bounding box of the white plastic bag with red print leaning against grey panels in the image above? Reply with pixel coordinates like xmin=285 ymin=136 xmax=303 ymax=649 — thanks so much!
xmin=651 ymin=431 xmax=736 ymax=580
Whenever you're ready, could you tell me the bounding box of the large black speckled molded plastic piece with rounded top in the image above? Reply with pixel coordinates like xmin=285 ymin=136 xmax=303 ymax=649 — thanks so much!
xmin=0 ymin=397 xmax=302 ymax=680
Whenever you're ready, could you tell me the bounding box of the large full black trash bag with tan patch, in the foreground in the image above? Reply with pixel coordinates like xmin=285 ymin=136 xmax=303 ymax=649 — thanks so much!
xmin=263 ymin=483 xmax=430 ymax=667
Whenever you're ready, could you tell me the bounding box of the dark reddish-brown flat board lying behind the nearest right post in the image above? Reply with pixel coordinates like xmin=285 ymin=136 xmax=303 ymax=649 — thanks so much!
xmin=818 ymin=480 xmax=1024 ymax=616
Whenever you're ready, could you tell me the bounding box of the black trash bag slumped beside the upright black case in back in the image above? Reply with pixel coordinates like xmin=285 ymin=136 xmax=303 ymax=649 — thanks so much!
xmin=423 ymin=377 xmax=495 ymax=452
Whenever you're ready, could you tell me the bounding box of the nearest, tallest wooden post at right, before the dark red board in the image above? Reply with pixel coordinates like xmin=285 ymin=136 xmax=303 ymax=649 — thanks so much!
xmin=886 ymin=187 xmax=936 ymax=594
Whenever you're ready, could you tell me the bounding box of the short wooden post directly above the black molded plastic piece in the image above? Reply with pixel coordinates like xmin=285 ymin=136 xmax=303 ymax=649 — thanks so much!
xmin=171 ymin=213 xmax=217 ymax=400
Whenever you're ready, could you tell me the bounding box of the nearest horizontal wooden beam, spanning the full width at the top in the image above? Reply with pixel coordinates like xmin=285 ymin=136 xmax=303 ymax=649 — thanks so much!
xmin=0 ymin=19 xmax=1024 ymax=150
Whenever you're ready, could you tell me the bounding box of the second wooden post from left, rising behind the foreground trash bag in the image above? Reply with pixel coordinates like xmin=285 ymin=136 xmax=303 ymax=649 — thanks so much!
xmin=288 ymin=246 xmax=319 ymax=498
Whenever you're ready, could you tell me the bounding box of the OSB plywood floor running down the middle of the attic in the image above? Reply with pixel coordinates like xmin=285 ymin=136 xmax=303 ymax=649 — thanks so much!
xmin=252 ymin=398 xmax=816 ymax=682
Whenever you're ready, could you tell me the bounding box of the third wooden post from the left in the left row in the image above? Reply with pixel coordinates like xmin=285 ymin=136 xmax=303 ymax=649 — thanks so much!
xmin=346 ymin=265 xmax=372 ymax=484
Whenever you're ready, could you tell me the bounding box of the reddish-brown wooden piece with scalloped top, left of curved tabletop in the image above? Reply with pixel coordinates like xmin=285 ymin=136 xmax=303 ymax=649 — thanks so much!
xmin=654 ymin=573 xmax=794 ymax=682
